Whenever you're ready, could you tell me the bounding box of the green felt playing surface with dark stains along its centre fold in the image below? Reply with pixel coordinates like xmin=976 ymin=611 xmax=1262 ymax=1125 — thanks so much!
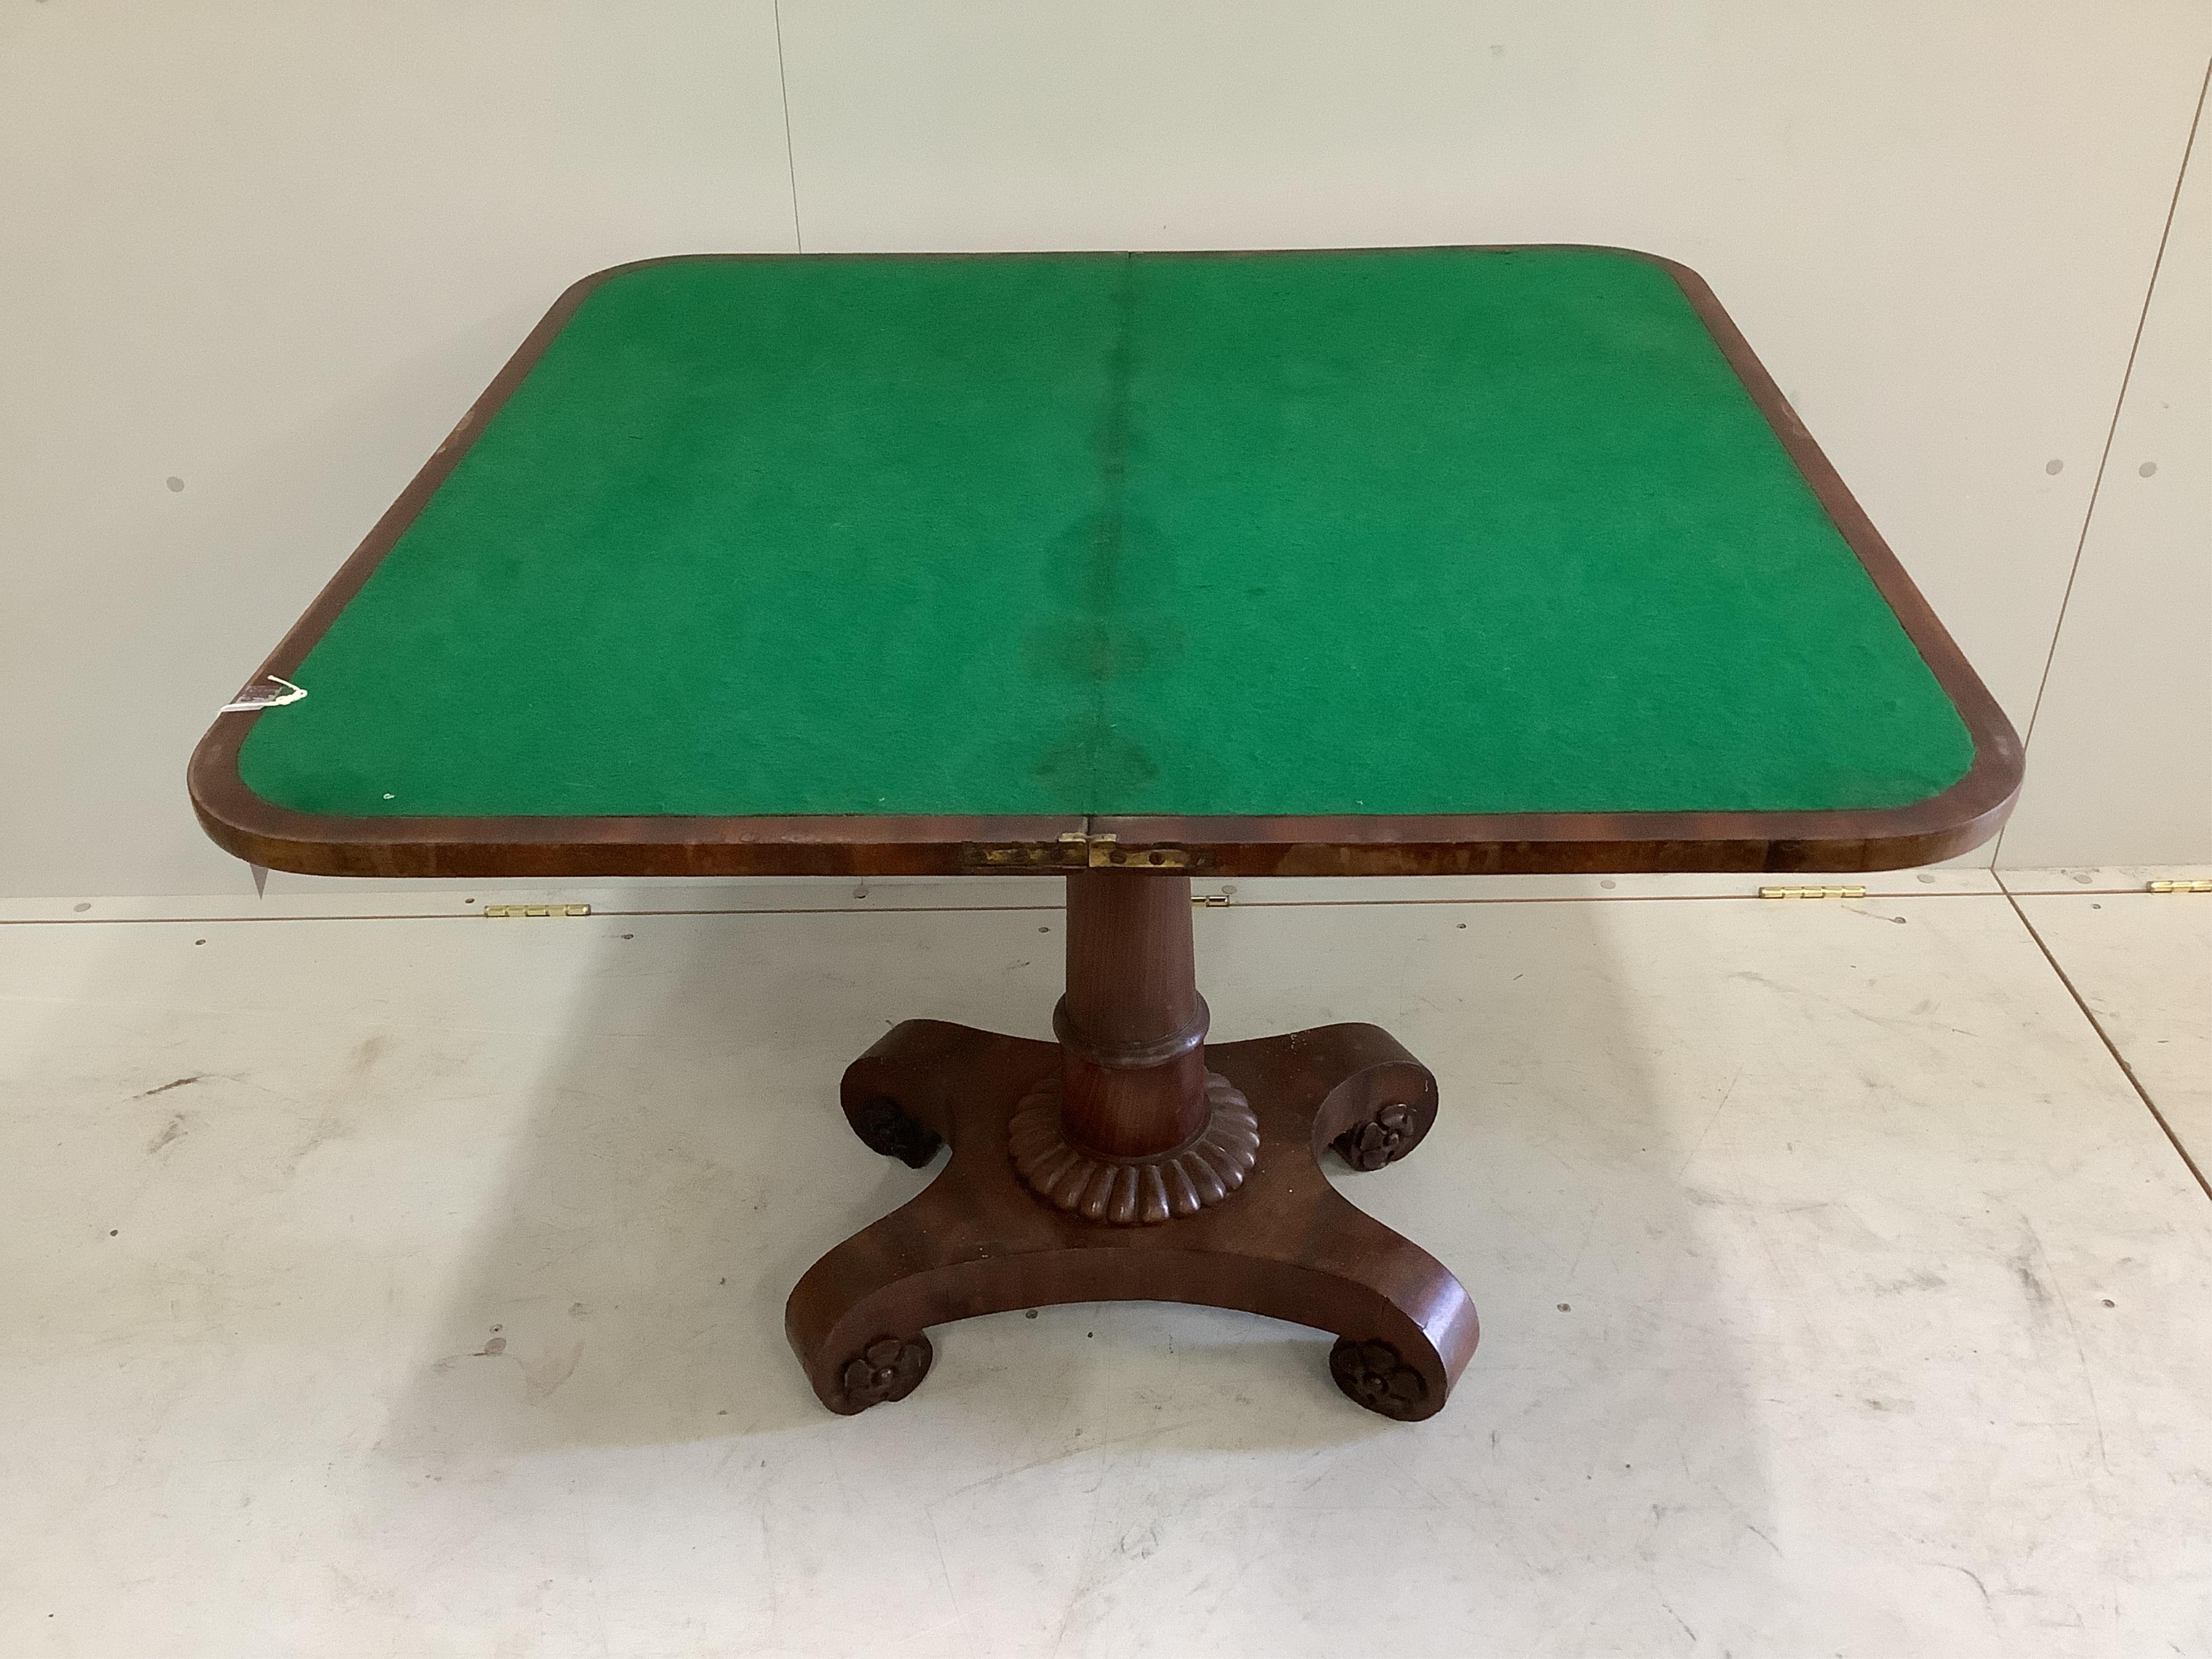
xmin=239 ymin=250 xmax=1973 ymax=816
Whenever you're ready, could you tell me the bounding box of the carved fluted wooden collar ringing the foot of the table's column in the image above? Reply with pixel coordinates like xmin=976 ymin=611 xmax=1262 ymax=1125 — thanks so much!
xmin=1007 ymin=1070 xmax=1259 ymax=1228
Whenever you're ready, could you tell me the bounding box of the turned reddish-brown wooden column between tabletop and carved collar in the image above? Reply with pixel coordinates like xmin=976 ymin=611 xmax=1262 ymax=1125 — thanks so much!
xmin=1053 ymin=869 xmax=1210 ymax=1159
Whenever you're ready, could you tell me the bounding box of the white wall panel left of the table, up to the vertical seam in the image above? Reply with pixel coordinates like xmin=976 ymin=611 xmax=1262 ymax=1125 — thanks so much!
xmin=0 ymin=0 xmax=792 ymax=894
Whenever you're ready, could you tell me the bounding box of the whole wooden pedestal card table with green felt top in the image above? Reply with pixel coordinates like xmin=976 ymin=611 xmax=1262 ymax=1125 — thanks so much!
xmin=190 ymin=248 xmax=2020 ymax=1420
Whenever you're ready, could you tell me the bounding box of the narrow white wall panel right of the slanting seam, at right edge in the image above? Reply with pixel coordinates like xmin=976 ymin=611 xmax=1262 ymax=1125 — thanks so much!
xmin=1998 ymin=112 xmax=2212 ymax=869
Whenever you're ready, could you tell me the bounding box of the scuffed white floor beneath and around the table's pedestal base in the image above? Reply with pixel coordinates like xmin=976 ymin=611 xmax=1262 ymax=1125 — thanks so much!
xmin=0 ymin=882 xmax=2212 ymax=1659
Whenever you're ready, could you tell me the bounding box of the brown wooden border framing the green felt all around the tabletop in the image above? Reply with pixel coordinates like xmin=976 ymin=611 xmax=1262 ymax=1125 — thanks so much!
xmin=188 ymin=244 xmax=2022 ymax=878
